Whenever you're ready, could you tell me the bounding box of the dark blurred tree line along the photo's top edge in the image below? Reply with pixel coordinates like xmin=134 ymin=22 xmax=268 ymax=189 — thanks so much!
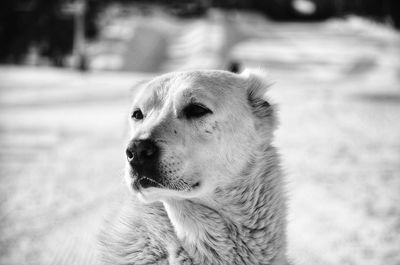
xmin=0 ymin=0 xmax=400 ymax=66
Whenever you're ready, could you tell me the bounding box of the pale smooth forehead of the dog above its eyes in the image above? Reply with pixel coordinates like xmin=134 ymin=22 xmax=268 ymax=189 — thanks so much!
xmin=136 ymin=71 xmax=241 ymax=108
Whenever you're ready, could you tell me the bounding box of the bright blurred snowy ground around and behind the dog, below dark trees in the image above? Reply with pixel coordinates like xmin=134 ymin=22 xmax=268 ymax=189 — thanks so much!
xmin=0 ymin=9 xmax=400 ymax=265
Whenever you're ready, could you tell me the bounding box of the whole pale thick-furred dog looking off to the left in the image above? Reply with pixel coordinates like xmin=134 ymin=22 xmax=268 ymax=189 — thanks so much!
xmin=101 ymin=70 xmax=289 ymax=265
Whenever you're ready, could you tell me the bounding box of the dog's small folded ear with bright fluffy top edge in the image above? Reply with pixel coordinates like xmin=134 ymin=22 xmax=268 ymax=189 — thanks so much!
xmin=240 ymin=70 xmax=276 ymax=132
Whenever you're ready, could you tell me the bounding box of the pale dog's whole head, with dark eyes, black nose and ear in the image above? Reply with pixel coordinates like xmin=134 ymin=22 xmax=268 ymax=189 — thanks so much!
xmin=126 ymin=71 xmax=274 ymax=202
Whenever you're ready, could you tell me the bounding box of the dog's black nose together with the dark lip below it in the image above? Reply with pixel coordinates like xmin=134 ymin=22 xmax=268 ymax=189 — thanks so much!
xmin=126 ymin=140 xmax=163 ymax=189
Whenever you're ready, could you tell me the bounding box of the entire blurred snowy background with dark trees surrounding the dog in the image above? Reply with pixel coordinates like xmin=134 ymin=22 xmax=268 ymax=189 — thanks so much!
xmin=0 ymin=0 xmax=400 ymax=265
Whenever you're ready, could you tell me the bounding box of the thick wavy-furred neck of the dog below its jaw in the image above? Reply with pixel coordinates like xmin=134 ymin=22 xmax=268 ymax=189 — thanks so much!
xmin=164 ymin=147 xmax=286 ymax=265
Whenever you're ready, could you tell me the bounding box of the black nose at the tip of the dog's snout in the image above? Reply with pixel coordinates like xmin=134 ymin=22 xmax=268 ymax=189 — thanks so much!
xmin=126 ymin=140 xmax=159 ymax=165
